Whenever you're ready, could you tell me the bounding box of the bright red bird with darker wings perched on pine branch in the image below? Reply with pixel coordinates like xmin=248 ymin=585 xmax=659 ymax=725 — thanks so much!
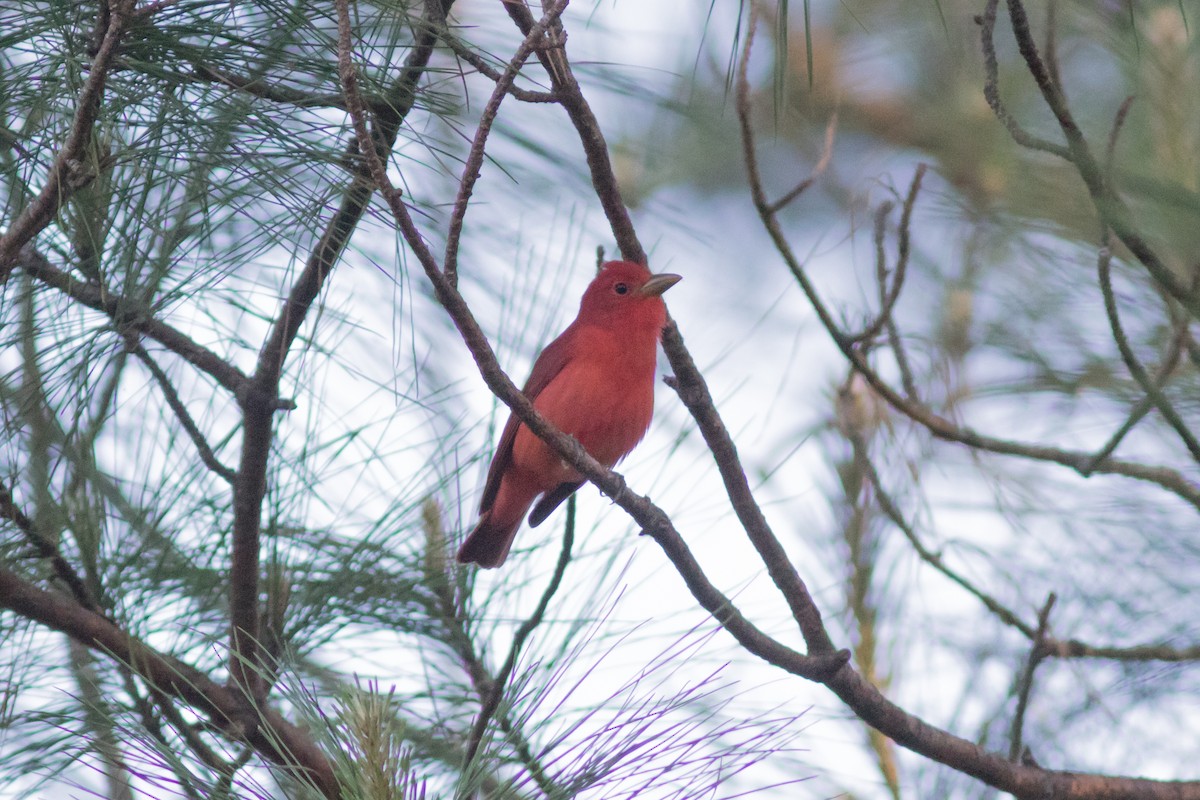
xmin=458 ymin=261 xmax=679 ymax=569
